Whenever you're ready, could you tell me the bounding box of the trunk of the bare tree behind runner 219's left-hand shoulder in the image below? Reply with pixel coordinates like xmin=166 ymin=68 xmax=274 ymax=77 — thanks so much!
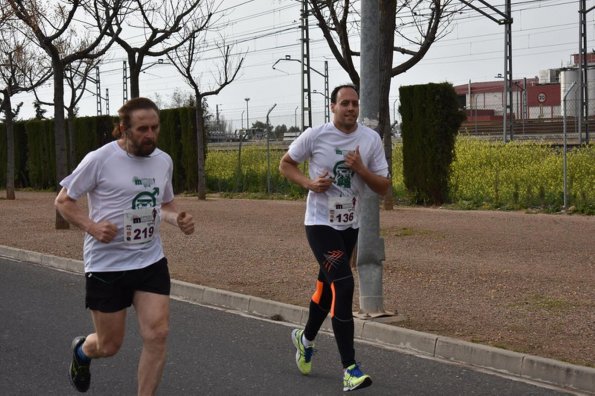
xmin=52 ymin=59 xmax=70 ymax=230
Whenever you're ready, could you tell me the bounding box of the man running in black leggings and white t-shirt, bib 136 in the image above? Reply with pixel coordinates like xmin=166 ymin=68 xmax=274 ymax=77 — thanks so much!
xmin=279 ymin=85 xmax=390 ymax=391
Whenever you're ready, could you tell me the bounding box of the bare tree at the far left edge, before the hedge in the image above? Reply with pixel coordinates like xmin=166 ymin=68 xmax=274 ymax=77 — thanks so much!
xmin=0 ymin=21 xmax=52 ymax=199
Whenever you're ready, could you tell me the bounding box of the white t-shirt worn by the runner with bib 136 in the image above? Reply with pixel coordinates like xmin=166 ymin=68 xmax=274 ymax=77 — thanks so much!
xmin=288 ymin=122 xmax=388 ymax=230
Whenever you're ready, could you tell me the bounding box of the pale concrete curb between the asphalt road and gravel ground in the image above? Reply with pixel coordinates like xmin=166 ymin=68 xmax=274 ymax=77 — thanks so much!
xmin=0 ymin=245 xmax=595 ymax=395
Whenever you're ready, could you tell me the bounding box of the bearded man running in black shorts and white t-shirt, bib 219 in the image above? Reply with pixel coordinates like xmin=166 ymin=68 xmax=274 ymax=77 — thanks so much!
xmin=55 ymin=98 xmax=194 ymax=395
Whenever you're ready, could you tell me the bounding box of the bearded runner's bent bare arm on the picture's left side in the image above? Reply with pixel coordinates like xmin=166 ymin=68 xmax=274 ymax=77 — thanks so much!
xmin=54 ymin=187 xmax=118 ymax=243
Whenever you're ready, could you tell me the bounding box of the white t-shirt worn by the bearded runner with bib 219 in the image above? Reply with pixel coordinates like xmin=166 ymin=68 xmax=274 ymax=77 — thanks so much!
xmin=60 ymin=141 xmax=174 ymax=272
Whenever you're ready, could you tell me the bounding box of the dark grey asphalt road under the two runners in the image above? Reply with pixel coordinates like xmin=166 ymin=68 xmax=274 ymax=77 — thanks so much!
xmin=0 ymin=257 xmax=569 ymax=396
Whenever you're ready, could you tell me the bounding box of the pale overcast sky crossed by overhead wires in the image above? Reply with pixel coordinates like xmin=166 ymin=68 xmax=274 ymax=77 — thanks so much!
xmin=13 ymin=0 xmax=595 ymax=129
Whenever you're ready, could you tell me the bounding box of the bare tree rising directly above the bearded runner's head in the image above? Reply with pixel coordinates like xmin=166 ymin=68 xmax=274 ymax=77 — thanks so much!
xmin=109 ymin=0 xmax=213 ymax=98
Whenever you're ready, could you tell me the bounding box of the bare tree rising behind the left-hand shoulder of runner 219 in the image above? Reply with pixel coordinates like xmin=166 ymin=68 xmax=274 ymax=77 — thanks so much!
xmin=6 ymin=0 xmax=127 ymax=229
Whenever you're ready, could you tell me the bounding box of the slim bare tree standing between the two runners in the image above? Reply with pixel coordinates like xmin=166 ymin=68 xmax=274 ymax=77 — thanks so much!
xmin=167 ymin=32 xmax=245 ymax=199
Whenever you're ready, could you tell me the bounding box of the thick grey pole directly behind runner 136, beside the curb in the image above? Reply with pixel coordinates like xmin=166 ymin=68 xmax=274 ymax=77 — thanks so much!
xmin=357 ymin=0 xmax=385 ymax=315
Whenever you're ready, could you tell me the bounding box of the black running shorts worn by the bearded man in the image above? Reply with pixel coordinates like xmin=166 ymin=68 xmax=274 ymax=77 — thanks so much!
xmin=85 ymin=257 xmax=171 ymax=312
